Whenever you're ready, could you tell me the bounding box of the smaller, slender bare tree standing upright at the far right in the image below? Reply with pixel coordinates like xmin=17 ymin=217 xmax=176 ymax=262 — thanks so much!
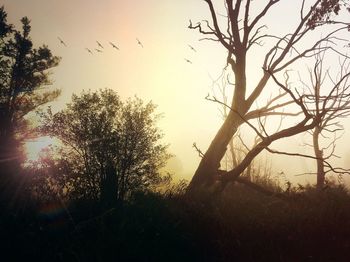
xmin=296 ymin=55 xmax=350 ymax=189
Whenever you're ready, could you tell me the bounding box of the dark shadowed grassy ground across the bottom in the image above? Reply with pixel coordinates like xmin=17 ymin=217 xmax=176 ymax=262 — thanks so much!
xmin=2 ymin=179 xmax=350 ymax=261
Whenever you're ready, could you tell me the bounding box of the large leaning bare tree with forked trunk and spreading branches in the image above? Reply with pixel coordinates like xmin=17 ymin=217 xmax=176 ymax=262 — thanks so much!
xmin=189 ymin=0 xmax=348 ymax=192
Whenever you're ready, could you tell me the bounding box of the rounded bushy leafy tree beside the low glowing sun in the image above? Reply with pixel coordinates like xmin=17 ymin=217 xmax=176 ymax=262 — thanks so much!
xmin=41 ymin=89 xmax=169 ymax=205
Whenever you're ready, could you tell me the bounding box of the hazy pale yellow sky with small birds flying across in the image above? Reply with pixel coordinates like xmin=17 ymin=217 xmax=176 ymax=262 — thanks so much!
xmin=2 ymin=0 xmax=348 ymax=184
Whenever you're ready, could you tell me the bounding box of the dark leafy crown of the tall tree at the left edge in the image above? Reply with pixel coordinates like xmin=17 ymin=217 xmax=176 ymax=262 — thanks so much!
xmin=0 ymin=7 xmax=60 ymax=143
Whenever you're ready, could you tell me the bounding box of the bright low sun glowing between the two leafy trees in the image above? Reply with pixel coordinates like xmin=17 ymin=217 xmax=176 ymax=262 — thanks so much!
xmin=24 ymin=136 xmax=55 ymax=162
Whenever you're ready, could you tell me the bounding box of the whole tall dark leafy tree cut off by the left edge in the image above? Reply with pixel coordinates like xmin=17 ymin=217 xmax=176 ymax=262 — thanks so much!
xmin=0 ymin=7 xmax=60 ymax=204
